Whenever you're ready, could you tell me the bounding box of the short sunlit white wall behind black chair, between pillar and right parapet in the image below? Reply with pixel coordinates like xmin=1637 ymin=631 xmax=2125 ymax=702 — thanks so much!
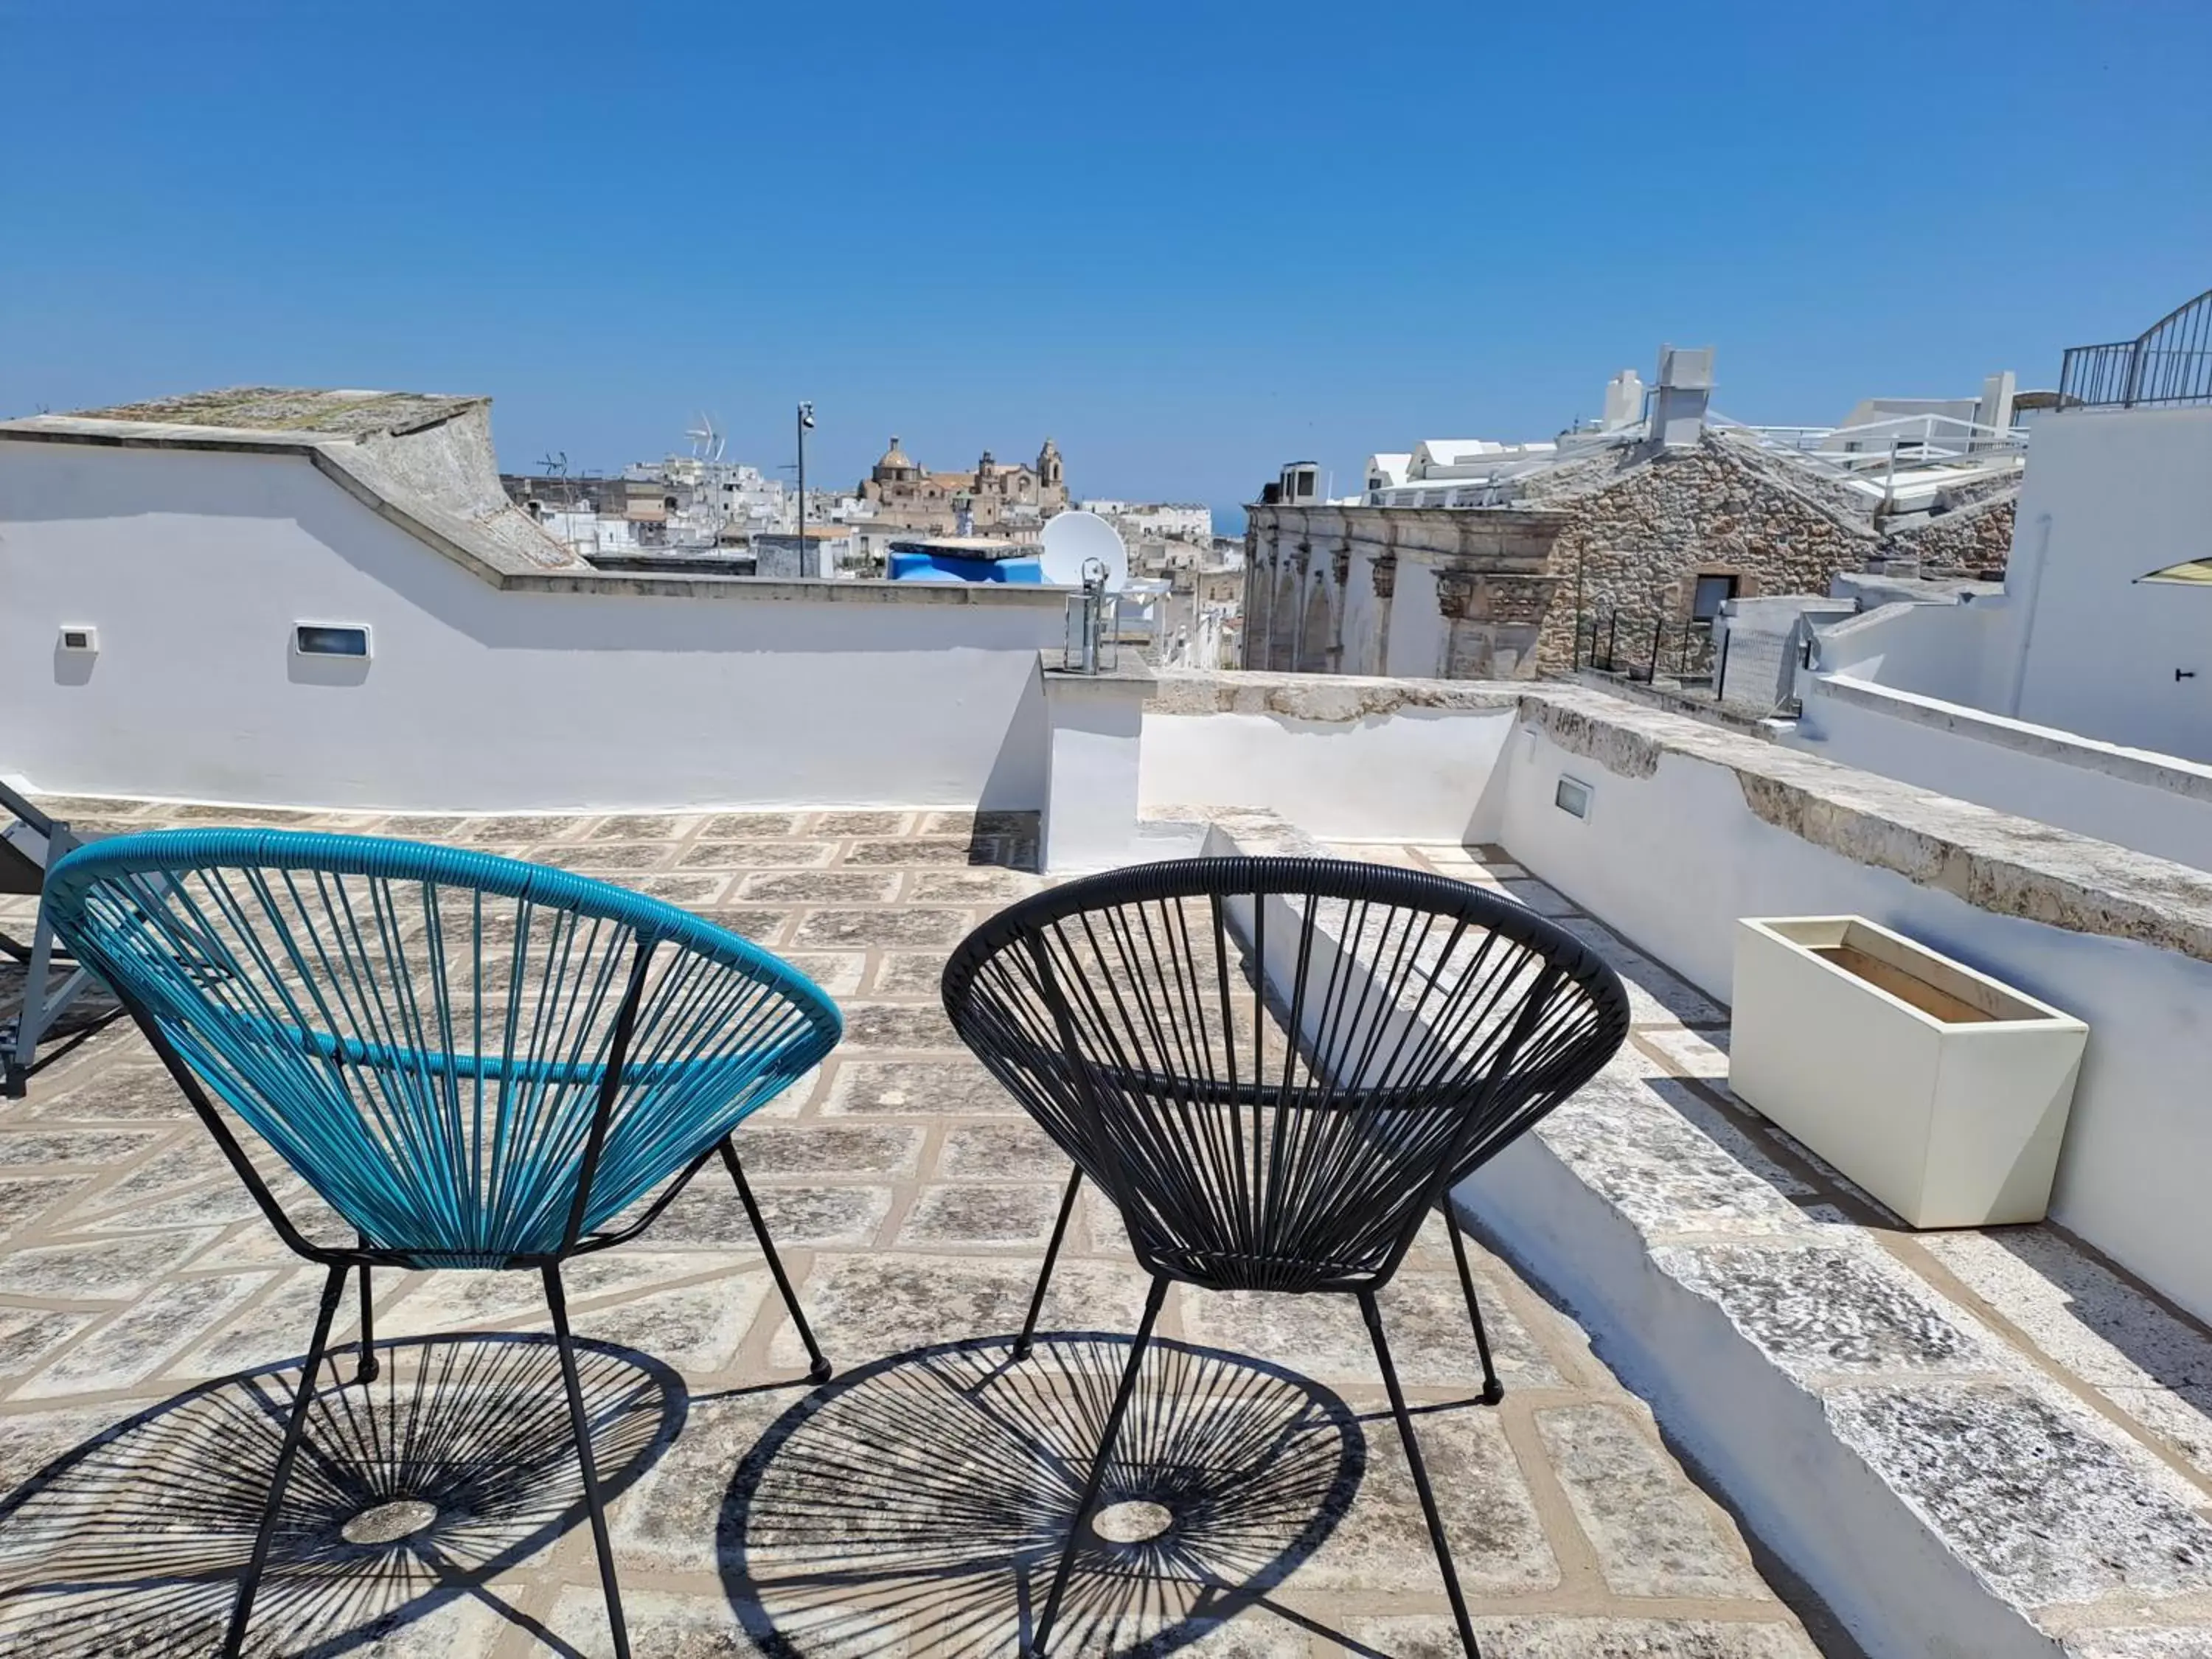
xmin=1139 ymin=708 xmax=1513 ymax=843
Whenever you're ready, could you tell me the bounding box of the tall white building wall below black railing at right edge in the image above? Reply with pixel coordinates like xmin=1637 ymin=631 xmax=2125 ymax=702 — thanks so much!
xmin=2000 ymin=409 xmax=2212 ymax=761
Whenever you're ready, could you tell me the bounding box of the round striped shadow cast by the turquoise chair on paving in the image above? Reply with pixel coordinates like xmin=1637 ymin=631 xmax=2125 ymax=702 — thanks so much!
xmin=0 ymin=1334 xmax=688 ymax=1659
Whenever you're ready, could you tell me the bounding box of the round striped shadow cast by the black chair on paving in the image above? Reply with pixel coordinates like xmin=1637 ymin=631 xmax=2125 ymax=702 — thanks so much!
xmin=719 ymin=1332 xmax=1367 ymax=1659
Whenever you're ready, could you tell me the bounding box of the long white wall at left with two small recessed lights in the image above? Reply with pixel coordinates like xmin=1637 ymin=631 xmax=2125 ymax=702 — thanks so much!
xmin=0 ymin=442 xmax=1064 ymax=812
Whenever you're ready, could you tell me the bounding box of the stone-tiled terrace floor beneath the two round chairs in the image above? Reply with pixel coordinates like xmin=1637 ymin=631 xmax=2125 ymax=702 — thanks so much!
xmin=0 ymin=803 xmax=1814 ymax=1659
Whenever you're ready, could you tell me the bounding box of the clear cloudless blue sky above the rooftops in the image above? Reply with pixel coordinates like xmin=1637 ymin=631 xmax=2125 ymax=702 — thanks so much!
xmin=0 ymin=0 xmax=2212 ymax=533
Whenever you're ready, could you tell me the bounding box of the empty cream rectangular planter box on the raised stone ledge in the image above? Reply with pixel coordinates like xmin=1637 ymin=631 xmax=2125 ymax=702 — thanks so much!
xmin=1728 ymin=916 xmax=2088 ymax=1228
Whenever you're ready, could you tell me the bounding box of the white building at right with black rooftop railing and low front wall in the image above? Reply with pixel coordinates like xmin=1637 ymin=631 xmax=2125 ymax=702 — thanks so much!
xmin=1787 ymin=296 xmax=2212 ymax=869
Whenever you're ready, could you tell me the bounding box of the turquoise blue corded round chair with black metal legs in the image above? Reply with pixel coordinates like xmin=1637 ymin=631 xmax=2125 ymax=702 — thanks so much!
xmin=46 ymin=830 xmax=843 ymax=1659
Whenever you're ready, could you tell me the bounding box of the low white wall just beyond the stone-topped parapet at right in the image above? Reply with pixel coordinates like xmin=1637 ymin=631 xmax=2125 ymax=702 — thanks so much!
xmin=1783 ymin=677 xmax=2212 ymax=869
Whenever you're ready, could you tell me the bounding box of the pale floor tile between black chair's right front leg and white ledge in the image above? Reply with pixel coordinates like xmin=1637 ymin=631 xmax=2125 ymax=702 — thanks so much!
xmin=1535 ymin=1405 xmax=1767 ymax=1601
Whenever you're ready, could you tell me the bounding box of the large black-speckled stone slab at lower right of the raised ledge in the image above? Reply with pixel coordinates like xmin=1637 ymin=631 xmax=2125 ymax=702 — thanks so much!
xmin=1827 ymin=1382 xmax=2212 ymax=1606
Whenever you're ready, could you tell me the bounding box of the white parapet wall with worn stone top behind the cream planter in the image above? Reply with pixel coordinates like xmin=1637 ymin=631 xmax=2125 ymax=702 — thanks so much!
xmin=1502 ymin=688 xmax=2212 ymax=1318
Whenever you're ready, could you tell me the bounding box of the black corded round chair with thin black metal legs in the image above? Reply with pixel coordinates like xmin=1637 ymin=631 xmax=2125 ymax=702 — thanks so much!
xmin=945 ymin=858 xmax=1628 ymax=1655
